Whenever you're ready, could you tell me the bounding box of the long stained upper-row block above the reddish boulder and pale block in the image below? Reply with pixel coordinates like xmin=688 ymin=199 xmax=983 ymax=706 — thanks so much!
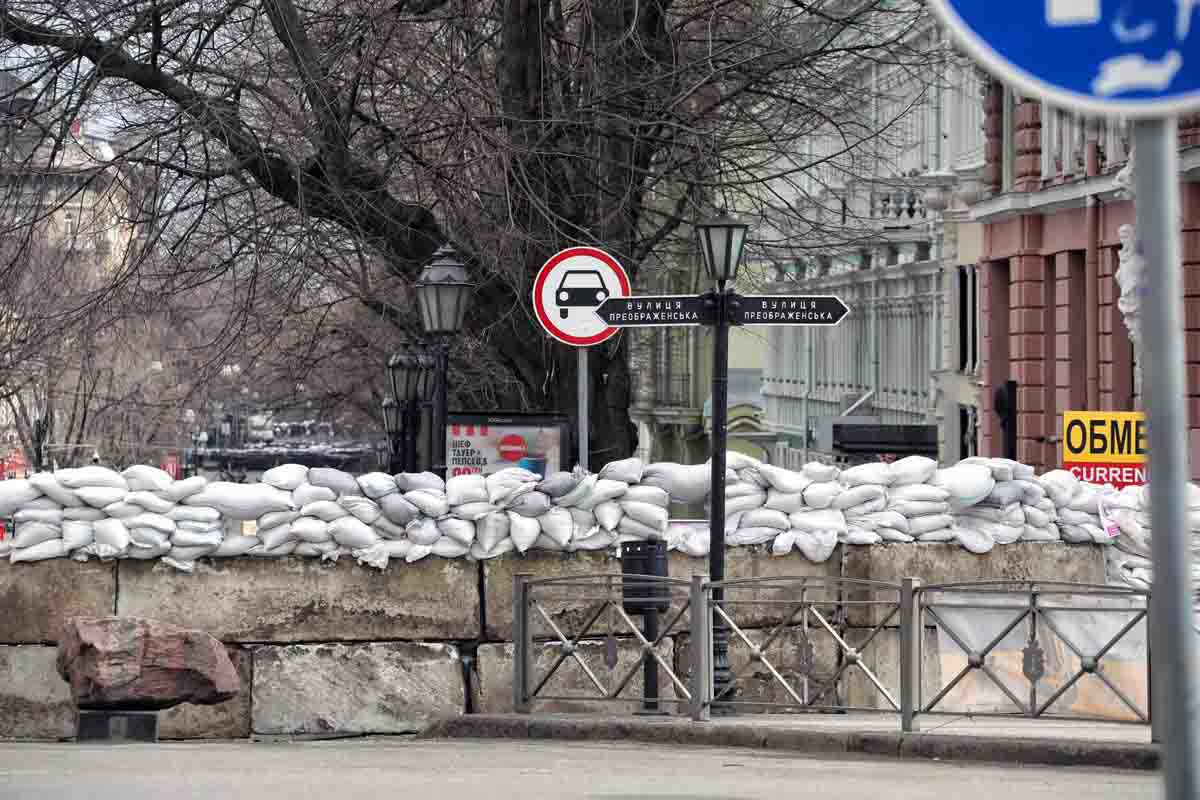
xmin=118 ymin=558 xmax=479 ymax=643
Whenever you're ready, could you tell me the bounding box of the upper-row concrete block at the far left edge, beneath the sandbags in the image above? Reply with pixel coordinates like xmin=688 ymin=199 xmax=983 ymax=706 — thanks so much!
xmin=0 ymin=559 xmax=116 ymax=644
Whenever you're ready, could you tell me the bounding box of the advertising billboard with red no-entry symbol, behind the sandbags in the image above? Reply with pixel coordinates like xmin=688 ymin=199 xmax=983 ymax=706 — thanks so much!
xmin=446 ymin=414 xmax=571 ymax=477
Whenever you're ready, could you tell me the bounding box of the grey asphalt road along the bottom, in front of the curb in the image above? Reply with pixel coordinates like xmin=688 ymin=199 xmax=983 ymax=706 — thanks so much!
xmin=0 ymin=739 xmax=1159 ymax=800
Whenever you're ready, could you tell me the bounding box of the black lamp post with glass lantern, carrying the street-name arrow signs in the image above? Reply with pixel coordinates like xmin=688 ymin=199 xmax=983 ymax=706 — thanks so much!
xmin=696 ymin=211 xmax=749 ymax=714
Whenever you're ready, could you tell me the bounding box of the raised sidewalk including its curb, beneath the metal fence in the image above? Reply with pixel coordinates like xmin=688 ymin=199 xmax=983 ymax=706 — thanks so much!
xmin=422 ymin=714 xmax=1159 ymax=770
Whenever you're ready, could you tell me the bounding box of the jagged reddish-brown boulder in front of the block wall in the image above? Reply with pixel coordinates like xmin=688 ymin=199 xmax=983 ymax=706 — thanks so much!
xmin=58 ymin=616 xmax=241 ymax=710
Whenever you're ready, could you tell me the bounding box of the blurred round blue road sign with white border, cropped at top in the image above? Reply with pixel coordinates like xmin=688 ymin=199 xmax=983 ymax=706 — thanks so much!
xmin=930 ymin=0 xmax=1200 ymax=116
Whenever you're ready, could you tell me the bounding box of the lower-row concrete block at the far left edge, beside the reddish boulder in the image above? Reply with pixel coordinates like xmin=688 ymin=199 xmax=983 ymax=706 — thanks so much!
xmin=0 ymin=645 xmax=76 ymax=739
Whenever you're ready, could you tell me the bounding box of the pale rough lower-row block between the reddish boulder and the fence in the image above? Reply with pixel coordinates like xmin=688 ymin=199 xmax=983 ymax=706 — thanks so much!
xmin=252 ymin=642 xmax=466 ymax=735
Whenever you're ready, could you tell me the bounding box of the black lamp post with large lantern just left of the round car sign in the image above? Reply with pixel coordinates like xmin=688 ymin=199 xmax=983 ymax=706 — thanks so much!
xmin=416 ymin=245 xmax=474 ymax=477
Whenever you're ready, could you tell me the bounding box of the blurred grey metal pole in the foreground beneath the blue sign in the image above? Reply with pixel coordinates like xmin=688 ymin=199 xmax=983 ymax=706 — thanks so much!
xmin=1133 ymin=118 xmax=1200 ymax=800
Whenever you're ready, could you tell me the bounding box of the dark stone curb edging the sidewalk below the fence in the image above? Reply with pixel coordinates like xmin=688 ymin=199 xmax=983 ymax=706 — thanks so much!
xmin=419 ymin=714 xmax=1160 ymax=770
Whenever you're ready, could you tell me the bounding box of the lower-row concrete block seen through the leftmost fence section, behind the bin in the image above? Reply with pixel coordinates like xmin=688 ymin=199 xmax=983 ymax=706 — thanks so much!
xmin=475 ymin=638 xmax=680 ymax=714
